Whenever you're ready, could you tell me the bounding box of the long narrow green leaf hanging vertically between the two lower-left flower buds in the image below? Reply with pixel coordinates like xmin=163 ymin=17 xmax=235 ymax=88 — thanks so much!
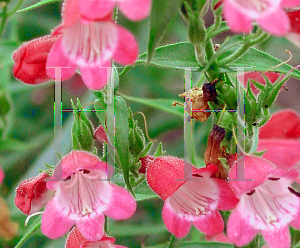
xmin=115 ymin=96 xmax=134 ymax=195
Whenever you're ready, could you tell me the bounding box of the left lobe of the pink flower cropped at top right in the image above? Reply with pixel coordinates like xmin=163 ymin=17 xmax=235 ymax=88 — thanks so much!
xmin=224 ymin=0 xmax=252 ymax=33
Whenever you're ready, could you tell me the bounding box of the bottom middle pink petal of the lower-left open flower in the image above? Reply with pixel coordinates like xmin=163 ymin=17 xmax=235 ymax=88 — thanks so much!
xmin=76 ymin=213 xmax=105 ymax=241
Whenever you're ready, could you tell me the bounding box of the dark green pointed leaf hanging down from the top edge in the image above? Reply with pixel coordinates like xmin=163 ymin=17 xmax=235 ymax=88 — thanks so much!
xmin=147 ymin=0 xmax=183 ymax=63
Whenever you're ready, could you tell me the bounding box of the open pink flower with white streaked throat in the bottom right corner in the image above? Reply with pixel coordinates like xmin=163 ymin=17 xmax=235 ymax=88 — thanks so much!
xmin=227 ymin=156 xmax=300 ymax=248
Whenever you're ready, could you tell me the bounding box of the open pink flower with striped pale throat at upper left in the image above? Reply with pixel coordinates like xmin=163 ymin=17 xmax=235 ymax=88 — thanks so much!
xmin=46 ymin=0 xmax=138 ymax=90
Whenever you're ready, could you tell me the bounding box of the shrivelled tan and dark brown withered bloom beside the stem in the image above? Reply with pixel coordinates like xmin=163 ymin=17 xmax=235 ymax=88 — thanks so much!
xmin=179 ymin=81 xmax=216 ymax=122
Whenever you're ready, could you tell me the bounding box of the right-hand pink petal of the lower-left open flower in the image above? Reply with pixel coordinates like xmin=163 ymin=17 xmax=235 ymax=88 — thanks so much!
xmin=103 ymin=184 xmax=136 ymax=220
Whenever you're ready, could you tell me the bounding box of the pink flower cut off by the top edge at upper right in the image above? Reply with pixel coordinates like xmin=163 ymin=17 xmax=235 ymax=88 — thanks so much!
xmin=224 ymin=0 xmax=300 ymax=36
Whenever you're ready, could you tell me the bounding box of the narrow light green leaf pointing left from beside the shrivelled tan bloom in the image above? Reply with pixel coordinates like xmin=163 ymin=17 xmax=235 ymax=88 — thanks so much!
xmin=122 ymin=94 xmax=184 ymax=117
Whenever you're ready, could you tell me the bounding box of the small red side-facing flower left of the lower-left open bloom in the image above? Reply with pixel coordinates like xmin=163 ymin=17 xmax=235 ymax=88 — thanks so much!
xmin=15 ymin=172 xmax=54 ymax=214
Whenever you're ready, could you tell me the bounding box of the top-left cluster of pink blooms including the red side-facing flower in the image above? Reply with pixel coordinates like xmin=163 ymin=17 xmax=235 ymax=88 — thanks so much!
xmin=13 ymin=0 xmax=151 ymax=90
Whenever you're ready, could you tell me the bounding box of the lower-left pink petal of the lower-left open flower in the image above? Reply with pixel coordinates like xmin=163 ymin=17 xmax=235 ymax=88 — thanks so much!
xmin=41 ymin=198 xmax=74 ymax=239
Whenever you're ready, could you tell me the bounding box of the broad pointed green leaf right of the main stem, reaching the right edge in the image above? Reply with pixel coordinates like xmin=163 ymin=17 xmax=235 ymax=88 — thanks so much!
xmin=230 ymin=47 xmax=300 ymax=79
